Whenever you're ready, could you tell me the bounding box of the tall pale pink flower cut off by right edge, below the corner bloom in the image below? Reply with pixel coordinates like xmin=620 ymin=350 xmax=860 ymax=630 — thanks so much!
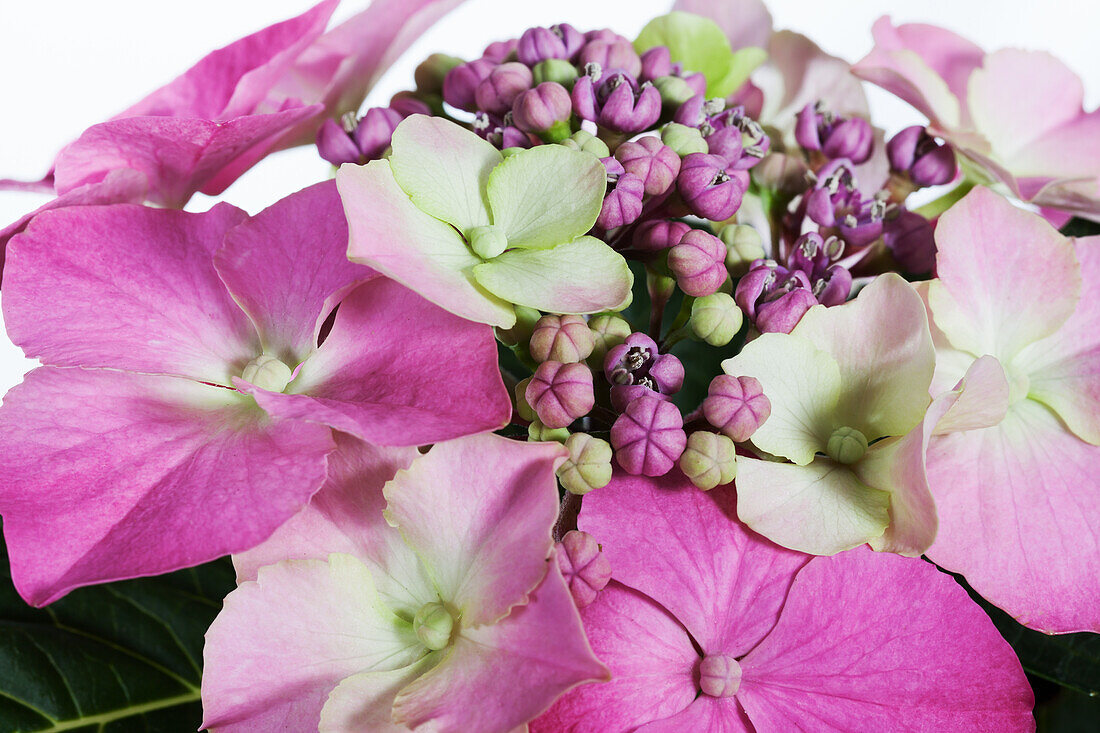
xmin=921 ymin=188 xmax=1100 ymax=633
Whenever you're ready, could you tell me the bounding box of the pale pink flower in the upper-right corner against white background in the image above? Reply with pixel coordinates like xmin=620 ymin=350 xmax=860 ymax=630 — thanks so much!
xmin=853 ymin=18 xmax=1100 ymax=219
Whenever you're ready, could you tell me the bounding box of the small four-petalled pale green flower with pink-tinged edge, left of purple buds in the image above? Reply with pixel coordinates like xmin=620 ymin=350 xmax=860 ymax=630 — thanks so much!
xmin=337 ymin=114 xmax=634 ymax=328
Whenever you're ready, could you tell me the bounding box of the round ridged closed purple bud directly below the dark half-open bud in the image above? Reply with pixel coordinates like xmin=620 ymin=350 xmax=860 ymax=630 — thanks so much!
xmin=612 ymin=395 xmax=688 ymax=477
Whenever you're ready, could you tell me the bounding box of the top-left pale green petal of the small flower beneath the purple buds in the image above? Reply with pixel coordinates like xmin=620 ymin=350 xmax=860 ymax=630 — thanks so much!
xmin=389 ymin=114 xmax=503 ymax=232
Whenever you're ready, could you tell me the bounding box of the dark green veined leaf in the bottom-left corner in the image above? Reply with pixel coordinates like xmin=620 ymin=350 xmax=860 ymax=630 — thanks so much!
xmin=0 ymin=530 xmax=234 ymax=733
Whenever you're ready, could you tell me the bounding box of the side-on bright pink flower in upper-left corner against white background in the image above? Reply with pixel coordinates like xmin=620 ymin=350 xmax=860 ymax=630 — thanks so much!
xmin=0 ymin=0 xmax=461 ymax=265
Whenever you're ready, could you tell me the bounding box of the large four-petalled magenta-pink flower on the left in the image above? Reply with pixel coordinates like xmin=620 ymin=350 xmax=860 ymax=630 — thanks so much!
xmin=0 ymin=182 xmax=510 ymax=605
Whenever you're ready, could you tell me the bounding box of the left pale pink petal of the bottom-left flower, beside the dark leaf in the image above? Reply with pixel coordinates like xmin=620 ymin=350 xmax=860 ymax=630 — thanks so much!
xmin=202 ymin=555 xmax=426 ymax=732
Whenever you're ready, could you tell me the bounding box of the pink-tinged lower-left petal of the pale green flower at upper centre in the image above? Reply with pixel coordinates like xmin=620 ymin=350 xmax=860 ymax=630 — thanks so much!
xmin=337 ymin=161 xmax=516 ymax=328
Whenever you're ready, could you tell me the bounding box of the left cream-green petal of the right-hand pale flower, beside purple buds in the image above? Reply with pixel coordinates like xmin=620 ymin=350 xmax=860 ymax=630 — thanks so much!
xmin=722 ymin=333 xmax=842 ymax=466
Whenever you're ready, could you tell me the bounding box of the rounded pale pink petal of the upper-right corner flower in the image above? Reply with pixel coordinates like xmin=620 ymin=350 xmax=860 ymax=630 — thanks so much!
xmin=967 ymin=48 xmax=1082 ymax=168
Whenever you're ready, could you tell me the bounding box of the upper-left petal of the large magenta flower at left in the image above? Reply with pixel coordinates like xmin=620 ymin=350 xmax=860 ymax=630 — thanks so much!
xmin=3 ymin=197 xmax=260 ymax=385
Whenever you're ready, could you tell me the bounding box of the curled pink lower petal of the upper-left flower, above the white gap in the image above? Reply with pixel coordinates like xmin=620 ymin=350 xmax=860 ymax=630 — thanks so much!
xmin=54 ymin=105 xmax=321 ymax=208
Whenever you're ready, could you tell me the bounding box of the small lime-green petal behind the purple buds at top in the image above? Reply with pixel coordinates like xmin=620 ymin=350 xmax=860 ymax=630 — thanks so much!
xmin=634 ymin=11 xmax=768 ymax=97
